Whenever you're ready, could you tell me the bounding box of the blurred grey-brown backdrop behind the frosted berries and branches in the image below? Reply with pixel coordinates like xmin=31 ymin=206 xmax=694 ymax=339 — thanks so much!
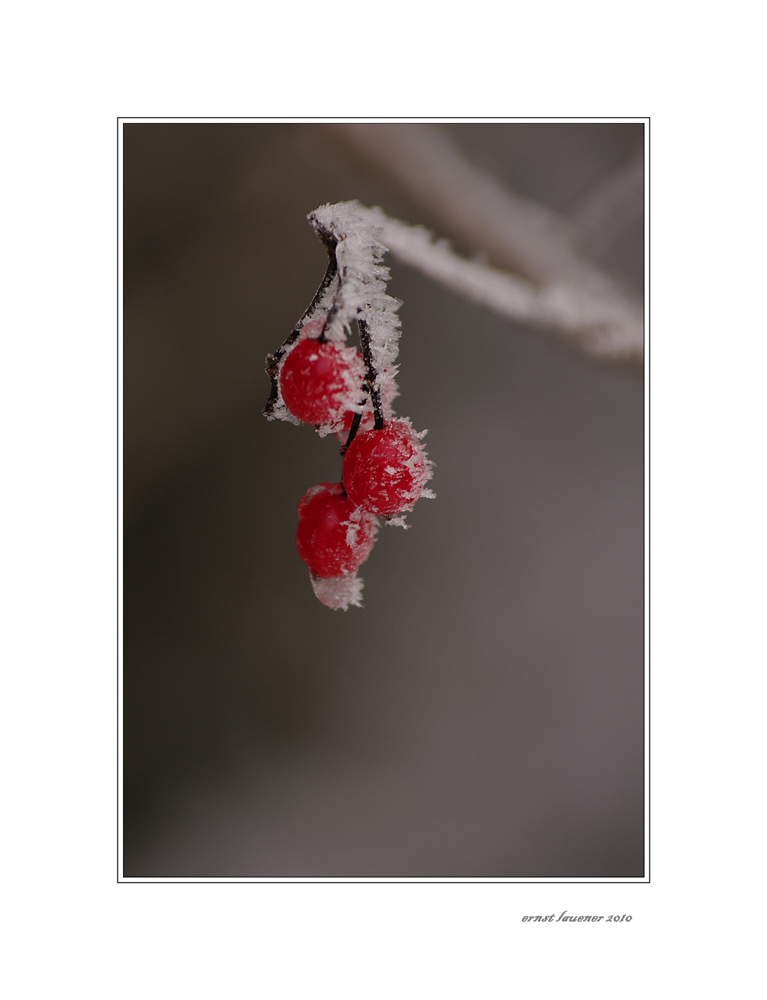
xmin=124 ymin=123 xmax=644 ymax=878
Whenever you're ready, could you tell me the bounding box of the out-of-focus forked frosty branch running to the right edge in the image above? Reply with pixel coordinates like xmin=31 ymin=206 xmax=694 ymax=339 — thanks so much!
xmin=329 ymin=123 xmax=643 ymax=361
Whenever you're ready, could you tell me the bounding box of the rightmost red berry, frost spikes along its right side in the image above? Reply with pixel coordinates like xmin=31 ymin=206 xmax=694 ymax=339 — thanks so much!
xmin=343 ymin=419 xmax=432 ymax=518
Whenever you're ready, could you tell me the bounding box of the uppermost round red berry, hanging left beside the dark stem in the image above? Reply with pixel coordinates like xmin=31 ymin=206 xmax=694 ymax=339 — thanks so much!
xmin=280 ymin=337 xmax=365 ymax=427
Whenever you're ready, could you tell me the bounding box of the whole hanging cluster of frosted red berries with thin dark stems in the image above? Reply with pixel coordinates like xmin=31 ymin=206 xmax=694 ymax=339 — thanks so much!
xmin=265 ymin=203 xmax=433 ymax=609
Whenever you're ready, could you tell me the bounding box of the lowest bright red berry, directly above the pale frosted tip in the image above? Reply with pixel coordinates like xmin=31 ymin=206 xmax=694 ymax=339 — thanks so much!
xmin=296 ymin=483 xmax=378 ymax=577
